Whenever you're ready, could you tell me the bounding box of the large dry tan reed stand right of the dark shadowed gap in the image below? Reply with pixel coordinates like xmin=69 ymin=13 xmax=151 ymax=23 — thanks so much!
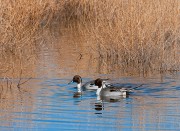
xmin=69 ymin=0 xmax=180 ymax=72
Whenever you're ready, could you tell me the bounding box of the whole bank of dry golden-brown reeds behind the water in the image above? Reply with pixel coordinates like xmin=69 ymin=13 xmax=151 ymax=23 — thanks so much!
xmin=0 ymin=0 xmax=180 ymax=72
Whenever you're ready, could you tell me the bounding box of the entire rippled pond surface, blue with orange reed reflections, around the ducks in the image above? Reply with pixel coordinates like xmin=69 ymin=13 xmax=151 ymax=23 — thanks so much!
xmin=0 ymin=37 xmax=180 ymax=130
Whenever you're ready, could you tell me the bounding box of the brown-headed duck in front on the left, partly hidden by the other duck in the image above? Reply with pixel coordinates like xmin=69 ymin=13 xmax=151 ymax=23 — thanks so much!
xmin=68 ymin=75 xmax=110 ymax=92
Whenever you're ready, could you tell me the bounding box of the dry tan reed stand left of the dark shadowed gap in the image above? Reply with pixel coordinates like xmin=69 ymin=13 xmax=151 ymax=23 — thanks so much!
xmin=0 ymin=0 xmax=58 ymax=77
